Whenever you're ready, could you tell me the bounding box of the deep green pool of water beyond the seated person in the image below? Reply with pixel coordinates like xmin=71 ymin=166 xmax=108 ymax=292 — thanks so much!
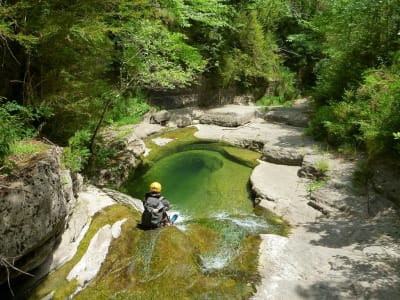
xmin=127 ymin=150 xmax=253 ymax=219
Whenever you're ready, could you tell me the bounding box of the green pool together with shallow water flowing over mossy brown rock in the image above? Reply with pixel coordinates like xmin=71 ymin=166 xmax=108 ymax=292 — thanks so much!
xmin=30 ymin=141 xmax=287 ymax=300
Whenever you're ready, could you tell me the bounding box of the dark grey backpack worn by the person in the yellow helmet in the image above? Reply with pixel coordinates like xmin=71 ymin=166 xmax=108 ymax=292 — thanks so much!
xmin=141 ymin=195 xmax=164 ymax=229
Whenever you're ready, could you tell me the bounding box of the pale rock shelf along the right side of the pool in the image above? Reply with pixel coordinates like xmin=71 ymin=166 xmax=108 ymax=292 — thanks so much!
xmin=192 ymin=104 xmax=400 ymax=300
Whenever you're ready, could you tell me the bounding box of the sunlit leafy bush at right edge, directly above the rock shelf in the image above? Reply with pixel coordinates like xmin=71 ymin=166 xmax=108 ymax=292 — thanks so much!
xmin=309 ymin=55 xmax=400 ymax=156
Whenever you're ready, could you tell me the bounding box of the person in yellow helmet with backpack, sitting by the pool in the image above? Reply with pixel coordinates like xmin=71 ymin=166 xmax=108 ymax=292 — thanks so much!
xmin=140 ymin=182 xmax=170 ymax=229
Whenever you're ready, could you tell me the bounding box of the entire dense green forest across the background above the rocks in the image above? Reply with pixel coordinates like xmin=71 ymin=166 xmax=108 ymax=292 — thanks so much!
xmin=0 ymin=0 xmax=400 ymax=169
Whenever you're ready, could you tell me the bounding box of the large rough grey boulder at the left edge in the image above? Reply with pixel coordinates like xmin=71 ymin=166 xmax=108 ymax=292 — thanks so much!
xmin=0 ymin=147 xmax=73 ymax=283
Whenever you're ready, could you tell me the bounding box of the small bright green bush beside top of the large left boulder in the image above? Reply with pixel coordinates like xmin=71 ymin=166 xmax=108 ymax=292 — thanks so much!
xmin=63 ymin=130 xmax=92 ymax=172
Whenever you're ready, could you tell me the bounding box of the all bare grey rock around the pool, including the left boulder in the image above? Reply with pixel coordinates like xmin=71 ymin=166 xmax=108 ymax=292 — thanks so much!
xmin=0 ymin=103 xmax=400 ymax=299
